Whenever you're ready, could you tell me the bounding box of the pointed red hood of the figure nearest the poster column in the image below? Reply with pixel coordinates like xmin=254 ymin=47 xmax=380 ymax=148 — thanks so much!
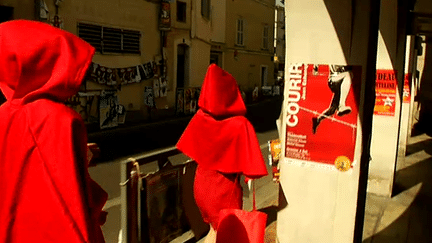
xmin=198 ymin=64 xmax=246 ymax=117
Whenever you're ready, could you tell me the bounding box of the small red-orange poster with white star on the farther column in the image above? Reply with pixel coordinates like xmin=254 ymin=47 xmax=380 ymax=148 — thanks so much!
xmin=374 ymin=70 xmax=397 ymax=116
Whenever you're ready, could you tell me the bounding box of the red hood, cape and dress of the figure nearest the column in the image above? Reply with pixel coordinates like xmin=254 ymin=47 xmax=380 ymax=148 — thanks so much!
xmin=177 ymin=64 xmax=267 ymax=230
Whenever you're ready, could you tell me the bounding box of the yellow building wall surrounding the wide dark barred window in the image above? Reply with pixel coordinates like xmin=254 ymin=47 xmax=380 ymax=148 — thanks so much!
xmin=46 ymin=0 xmax=161 ymax=113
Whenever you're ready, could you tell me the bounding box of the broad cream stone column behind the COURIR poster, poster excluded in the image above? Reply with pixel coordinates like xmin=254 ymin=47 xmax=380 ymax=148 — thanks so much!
xmin=277 ymin=0 xmax=380 ymax=243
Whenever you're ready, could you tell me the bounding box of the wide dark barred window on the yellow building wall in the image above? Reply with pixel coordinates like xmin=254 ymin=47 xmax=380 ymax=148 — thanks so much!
xmin=78 ymin=23 xmax=141 ymax=54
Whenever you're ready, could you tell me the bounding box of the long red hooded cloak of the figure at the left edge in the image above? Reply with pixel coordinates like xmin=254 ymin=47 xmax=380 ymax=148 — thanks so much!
xmin=0 ymin=20 xmax=107 ymax=243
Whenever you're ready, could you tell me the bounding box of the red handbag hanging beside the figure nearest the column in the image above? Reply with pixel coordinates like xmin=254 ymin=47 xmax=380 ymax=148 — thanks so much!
xmin=216 ymin=180 xmax=267 ymax=243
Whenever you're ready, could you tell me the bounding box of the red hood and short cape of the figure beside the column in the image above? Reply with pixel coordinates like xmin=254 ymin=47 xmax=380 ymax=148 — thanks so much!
xmin=177 ymin=64 xmax=267 ymax=178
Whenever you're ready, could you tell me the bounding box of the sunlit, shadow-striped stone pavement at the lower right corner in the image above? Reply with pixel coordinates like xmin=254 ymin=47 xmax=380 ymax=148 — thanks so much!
xmin=363 ymin=131 xmax=432 ymax=243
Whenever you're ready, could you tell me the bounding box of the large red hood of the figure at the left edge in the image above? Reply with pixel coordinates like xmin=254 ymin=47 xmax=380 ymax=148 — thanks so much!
xmin=0 ymin=20 xmax=94 ymax=104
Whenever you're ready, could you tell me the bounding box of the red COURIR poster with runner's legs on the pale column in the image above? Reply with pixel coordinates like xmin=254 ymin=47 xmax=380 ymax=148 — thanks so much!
xmin=284 ymin=64 xmax=361 ymax=171
